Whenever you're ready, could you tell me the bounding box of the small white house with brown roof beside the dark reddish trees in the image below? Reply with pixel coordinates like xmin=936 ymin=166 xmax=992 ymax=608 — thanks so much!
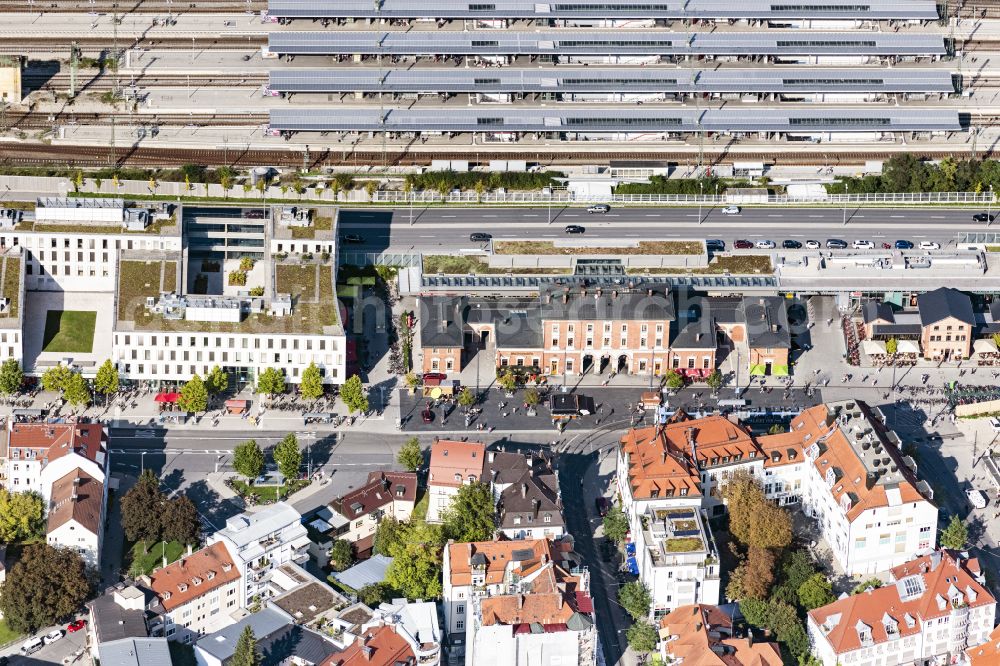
xmin=45 ymin=467 xmax=107 ymax=568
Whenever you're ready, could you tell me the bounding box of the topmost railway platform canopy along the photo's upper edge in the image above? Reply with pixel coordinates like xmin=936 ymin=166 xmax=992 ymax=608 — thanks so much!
xmin=267 ymin=0 xmax=939 ymax=21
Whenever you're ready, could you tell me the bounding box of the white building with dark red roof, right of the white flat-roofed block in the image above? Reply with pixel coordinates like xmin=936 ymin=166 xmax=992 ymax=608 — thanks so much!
xmin=327 ymin=472 xmax=417 ymax=560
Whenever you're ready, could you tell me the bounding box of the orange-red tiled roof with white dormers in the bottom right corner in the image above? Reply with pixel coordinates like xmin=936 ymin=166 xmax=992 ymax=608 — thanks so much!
xmin=809 ymin=550 xmax=994 ymax=654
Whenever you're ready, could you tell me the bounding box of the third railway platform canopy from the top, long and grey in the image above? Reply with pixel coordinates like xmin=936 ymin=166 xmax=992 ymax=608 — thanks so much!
xmin=268 ymin=66 xmax=956 ymax=95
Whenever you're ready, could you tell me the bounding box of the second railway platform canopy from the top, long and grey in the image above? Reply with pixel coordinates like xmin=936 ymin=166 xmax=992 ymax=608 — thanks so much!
xmin=268 ymin=29 xmax=947 ymax=57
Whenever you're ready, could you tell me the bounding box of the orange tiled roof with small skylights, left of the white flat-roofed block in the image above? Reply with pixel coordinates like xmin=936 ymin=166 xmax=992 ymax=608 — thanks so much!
xmin=149 ymin=541 xmax=240 ymax=611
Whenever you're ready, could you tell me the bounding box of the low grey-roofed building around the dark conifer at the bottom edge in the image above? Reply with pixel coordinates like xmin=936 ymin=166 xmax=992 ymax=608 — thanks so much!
xmin=194 ymin=608 xmax=337 ymax=666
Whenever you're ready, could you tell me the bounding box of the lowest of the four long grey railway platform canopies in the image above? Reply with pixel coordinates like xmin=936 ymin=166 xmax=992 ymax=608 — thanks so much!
xmin=270 ymin=106 xmax=962 ymax=136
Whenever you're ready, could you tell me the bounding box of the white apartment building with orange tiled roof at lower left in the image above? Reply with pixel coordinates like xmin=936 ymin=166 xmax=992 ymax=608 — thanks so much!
xmin=140 ymin=542 xmax=243 ymax=644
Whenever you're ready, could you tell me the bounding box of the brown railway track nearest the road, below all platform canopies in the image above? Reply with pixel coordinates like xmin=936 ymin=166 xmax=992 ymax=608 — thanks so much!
xmin=0 ymin=144 xmax=988 ymax=169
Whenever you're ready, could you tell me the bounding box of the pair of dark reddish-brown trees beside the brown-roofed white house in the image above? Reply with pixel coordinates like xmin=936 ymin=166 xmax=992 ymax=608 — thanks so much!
xmin=121 ymin=469 xmax=199 ymax=549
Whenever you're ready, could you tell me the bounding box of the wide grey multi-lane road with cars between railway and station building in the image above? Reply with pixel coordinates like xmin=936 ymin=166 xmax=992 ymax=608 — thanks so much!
xmin=339 ymin=206 xmax=1000 ymax=252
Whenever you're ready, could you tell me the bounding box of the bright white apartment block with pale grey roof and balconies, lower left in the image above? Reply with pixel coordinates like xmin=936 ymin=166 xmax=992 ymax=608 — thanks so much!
xmin=208 ymin=502 xmax=310 ymax=607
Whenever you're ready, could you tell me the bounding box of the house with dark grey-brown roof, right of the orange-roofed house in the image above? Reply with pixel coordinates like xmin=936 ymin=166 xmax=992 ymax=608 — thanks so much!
xmin=483 ymin=450 xmax=566 ymax=539
